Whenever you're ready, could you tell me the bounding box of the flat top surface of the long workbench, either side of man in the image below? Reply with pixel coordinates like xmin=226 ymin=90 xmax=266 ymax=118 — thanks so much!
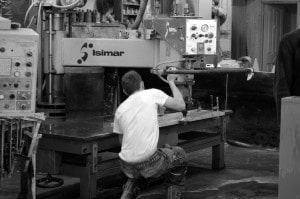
xmin=40 ymin=110 xmax=225 ymax=141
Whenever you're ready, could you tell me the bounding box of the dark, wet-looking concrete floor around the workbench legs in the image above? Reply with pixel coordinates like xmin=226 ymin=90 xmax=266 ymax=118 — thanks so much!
xmin=0 ymin=145 xmax=279 ymax=199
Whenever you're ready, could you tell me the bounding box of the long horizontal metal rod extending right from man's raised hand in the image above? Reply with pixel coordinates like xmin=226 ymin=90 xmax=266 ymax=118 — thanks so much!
xmin=164 ymin=68 xmax=252 ymax=74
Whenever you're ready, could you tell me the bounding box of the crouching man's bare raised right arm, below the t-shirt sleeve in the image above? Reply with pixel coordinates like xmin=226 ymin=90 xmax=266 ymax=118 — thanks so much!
xmin=164 ymin=75 xmax=185 ymax=111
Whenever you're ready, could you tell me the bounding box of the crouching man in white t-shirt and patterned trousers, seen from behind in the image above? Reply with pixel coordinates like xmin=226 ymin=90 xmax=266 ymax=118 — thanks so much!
xmin=113 ymin=71 xmax=187 ymax=199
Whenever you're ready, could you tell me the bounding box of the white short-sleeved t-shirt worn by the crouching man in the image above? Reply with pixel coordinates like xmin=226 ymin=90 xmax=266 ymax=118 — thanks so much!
xmin=113 ymin=89 xmax=168 ymax=163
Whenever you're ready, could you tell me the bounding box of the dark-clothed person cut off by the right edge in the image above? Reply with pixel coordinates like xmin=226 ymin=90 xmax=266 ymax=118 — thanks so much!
xmin=273 ymin=29 xmax=300 ymax=123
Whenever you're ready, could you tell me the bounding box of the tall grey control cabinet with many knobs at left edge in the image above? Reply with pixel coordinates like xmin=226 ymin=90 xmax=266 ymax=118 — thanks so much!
xmin=0 ymin=28 xmax=38 ymax=116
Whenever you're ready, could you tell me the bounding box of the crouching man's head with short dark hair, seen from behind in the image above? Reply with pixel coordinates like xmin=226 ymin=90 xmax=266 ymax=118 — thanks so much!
xmin=121 ymin=70 xmax=143 ymax=95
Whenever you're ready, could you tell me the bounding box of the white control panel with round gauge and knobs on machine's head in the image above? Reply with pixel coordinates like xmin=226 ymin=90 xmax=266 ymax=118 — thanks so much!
xmin=185 ymin=19 xmax=218 ymax=55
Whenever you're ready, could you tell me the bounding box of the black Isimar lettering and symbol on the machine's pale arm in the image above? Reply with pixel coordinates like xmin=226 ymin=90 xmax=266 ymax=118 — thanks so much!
xmin=77 ymin=42 xmax=125 ymax=64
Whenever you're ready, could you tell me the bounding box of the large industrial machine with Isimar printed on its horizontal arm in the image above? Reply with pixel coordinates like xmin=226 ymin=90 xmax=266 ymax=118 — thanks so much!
xmin=28 ymin=0 xmax=250 ymax=117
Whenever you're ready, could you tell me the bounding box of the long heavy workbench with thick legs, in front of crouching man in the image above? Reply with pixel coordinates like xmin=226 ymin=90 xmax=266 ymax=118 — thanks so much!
xmin=38 ymin=110 xmax=231 ymax=199
